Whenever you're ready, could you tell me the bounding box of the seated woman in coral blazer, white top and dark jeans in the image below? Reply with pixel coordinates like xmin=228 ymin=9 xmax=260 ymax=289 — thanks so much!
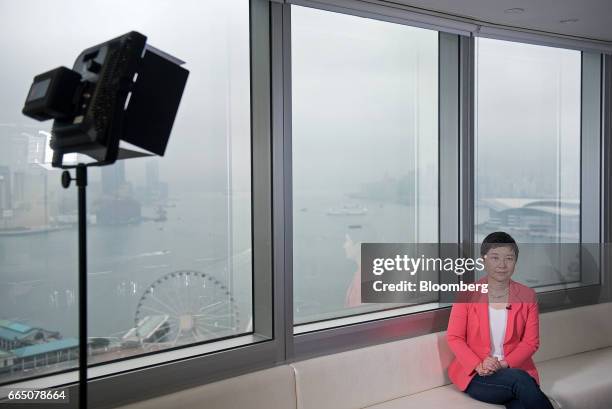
xmin=446 ymin=232 xmax=553 ymax=409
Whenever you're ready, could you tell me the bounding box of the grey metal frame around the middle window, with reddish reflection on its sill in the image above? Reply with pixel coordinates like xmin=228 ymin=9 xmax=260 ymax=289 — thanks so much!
xmin=284 ymin=1 xmax=467 ymax=361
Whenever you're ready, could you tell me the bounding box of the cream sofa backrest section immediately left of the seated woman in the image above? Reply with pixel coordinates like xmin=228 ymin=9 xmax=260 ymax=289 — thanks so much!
xmin=291 ymin=332 xmax=452 ymax=409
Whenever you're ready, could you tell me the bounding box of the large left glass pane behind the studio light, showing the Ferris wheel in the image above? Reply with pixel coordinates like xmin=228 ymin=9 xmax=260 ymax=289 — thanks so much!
xmin=0 ymin=0 xmax=252 ymax=382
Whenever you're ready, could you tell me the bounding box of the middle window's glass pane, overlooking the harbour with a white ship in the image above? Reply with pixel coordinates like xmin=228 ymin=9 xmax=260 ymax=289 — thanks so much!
xmin=291 ymin=6 xmax=438 ymax=324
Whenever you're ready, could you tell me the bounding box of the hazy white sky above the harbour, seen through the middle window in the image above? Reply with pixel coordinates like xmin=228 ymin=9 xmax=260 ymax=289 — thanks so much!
xmin=292 ymin=7 xmax=438 ymax=198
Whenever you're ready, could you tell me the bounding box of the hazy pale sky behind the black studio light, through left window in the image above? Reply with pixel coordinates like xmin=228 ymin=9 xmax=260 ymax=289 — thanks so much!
xmin=0 ymin=0 xmax=250 ymax=190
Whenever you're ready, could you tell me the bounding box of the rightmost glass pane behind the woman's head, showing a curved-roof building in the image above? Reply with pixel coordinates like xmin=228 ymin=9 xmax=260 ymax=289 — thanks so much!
xmin=475 ymin=38 xmax=581 ymax=287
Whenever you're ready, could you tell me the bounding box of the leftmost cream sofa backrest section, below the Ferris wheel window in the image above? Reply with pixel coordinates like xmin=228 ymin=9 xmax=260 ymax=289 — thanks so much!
xmin=116 ymin=365 xmax=296 ymax=409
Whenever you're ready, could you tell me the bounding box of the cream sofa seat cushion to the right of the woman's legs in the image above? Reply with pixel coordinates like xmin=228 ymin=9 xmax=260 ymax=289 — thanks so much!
xmin=538 ymin=348 xmax=612 ymax=409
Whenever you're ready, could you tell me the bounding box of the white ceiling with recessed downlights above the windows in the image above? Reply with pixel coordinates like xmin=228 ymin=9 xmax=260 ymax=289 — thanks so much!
xmin=388 ymin=0 xmax=612 ymax=41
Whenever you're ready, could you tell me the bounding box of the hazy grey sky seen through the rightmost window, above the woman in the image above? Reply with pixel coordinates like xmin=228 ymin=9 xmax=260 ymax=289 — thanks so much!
xmin=476 ymin=38 xmax=581 ymax=199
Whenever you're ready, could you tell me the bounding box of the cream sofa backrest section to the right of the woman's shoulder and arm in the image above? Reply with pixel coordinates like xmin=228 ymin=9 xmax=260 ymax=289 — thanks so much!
xmin=534 ymin=303 xmax=612 ymax=362
